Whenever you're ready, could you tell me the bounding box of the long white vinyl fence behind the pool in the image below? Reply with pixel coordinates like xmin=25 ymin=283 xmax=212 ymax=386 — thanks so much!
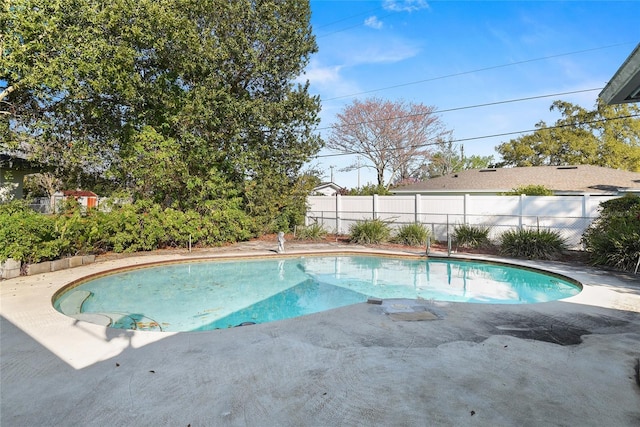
xmin=305 ymin=194 xmax=619 ymax=248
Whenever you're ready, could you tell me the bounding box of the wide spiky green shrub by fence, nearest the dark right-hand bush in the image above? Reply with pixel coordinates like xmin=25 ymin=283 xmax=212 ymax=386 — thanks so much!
xmin=500 ymin=229 xmax=566 ymax=260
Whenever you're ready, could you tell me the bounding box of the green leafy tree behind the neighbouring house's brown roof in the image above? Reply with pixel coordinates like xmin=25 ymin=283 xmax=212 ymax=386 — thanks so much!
xmin=496 ymin=101 xmax=640 ymax=172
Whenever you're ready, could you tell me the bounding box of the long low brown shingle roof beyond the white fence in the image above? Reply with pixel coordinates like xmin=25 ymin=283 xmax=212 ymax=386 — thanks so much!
xmin=392 ymin=165 xmax=640 ymax=194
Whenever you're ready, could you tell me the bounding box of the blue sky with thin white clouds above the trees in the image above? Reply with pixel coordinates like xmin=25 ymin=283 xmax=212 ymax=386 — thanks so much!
xmin=303 ymin=0 xmax=640 ymax=188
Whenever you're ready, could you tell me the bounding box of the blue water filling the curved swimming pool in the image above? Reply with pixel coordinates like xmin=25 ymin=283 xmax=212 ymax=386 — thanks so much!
xmin=54 ymin=255 xmax=580 ymax=331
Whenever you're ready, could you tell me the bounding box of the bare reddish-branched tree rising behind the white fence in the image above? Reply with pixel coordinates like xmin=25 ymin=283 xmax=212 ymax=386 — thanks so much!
xmin=327 ymin=98 xmax=450 ymax=187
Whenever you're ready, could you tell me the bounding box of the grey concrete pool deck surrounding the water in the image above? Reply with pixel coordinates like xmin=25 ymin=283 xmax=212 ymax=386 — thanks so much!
xmin=0 ymin=242 xmax=640 ymax=427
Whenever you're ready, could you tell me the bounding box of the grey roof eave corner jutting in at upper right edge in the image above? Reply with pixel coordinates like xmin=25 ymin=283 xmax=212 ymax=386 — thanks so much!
xmin=599 ymin=43 xmax=640 ymax=104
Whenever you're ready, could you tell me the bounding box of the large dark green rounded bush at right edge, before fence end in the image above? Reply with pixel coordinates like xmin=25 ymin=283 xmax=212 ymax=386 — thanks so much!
xmin=582 ymin=195 xmax=640 ymax=271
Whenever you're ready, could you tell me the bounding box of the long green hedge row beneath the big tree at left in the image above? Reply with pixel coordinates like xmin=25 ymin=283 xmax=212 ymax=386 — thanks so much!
xmin=0 ymin=201 xmax=255 ymax=263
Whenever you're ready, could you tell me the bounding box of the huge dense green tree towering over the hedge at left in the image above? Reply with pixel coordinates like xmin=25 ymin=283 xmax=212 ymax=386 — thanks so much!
xmin=0 ymin=0 xmax=321 ymax=227
